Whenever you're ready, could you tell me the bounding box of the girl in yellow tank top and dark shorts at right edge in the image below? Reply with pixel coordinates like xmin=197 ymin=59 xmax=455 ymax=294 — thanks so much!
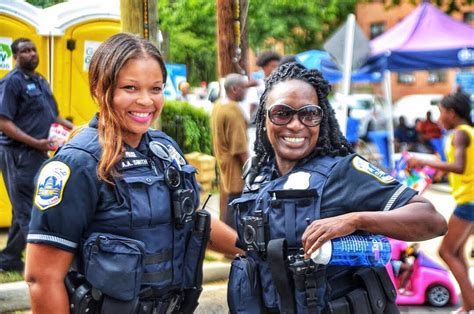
xmin=408 ymin=93 xmax=474 ymax=313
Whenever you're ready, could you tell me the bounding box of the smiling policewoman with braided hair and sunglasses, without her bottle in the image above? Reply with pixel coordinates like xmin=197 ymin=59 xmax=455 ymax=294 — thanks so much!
xmin=228 ymin=63 xmax=446 ymax=313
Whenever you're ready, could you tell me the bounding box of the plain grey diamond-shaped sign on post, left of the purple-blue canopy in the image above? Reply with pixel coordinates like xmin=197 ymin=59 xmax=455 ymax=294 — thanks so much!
xmin=323 ymin=22 xmax=370 ymax=70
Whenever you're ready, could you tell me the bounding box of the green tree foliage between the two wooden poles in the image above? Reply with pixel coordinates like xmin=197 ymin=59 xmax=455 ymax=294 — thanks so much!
xmin=158 ymin=0 xmax=217 ymax=85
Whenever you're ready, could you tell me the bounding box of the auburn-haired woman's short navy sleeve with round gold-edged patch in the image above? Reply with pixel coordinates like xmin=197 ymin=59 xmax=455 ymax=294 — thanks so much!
xmin=27 ymin=149 xmax=98 ymax=252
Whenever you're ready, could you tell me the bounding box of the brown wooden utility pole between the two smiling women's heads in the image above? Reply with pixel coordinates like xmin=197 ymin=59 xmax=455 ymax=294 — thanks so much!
xmin=216 ymin=0 xmax=248 ymax=77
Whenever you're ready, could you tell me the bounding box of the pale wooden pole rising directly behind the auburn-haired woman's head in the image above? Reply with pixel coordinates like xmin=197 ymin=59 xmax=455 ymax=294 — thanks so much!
xmin=120 ymin=0 xmax=159 ymax=47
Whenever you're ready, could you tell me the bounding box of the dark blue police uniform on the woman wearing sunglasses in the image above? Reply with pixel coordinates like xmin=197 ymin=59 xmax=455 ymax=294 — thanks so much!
xmin=228 ymin=155 xmax=416 ymax=313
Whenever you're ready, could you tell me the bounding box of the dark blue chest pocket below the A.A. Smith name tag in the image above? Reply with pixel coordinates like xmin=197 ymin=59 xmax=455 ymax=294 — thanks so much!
xmin=123 ymin=175 xmax=171 ymax=228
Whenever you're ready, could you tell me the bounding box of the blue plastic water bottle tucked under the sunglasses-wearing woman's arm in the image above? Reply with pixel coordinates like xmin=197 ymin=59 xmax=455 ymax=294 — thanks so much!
xmin=311 ymin=234 xmax=391 ymax=266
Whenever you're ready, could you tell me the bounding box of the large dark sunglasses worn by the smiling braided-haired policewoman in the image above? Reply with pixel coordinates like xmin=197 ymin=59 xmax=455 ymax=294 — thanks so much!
xmin=267 ymin=103 xmax=323 ymax=127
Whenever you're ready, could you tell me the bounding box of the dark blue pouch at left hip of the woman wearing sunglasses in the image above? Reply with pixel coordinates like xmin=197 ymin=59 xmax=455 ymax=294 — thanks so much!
xmin=227 ymin=256 xmax=263 ymax=314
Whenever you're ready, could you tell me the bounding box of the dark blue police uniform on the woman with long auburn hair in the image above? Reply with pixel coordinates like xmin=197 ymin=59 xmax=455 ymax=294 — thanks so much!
xmin=27 ymin=118 xmax=209 ymax=313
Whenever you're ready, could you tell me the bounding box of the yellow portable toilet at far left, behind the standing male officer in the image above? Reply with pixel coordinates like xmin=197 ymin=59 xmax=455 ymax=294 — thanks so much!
xmin=0 ymin=0 xmax=49 ymax=227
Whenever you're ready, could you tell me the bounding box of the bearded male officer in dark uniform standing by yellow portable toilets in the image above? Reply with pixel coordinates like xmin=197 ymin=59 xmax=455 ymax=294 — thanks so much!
xmin=0 ymin=38 xmax=72 ymax=271
